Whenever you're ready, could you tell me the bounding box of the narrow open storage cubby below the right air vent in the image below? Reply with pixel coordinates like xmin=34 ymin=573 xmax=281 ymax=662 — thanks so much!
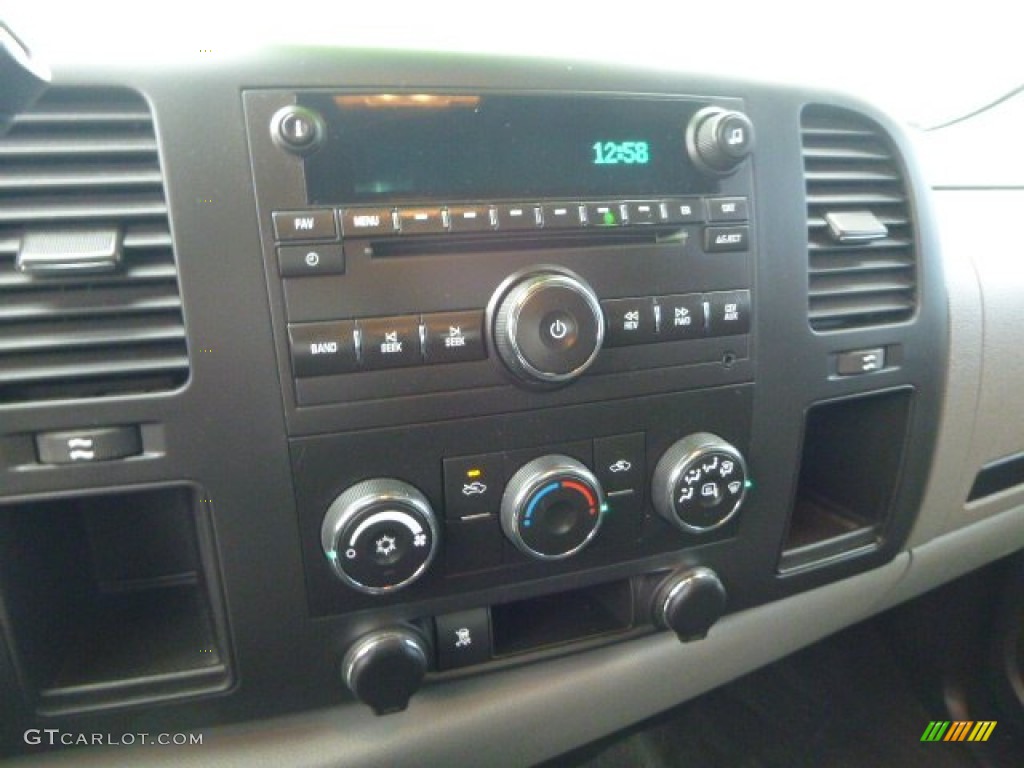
xmin=779 ymin=389 xmax=911 ymax=572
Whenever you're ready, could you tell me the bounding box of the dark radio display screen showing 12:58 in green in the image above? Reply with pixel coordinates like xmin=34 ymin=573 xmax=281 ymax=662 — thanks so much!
xmin=298 ymin=93 xmax=712 ymax=205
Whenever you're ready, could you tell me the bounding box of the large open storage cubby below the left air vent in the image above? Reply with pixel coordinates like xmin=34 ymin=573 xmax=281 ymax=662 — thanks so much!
xmin=0 ymin=487 xmax=229 ymax=714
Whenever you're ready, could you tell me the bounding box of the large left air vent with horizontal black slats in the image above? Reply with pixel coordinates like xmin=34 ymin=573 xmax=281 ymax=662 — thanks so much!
xmin=0 ymin=88 xmax=188 ymax=403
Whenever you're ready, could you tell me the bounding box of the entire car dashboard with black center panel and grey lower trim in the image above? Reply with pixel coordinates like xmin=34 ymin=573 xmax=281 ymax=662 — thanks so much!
xmin=0 ymin=19 xmax=1024 ymax=766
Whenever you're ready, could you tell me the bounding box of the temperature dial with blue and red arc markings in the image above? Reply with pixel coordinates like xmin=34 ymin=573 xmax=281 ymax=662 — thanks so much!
xmin=501 ymin=455 xmax=605 ymax=560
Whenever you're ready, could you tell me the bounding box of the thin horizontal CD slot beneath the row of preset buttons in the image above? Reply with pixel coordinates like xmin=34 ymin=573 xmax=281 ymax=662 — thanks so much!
xmin=367 ymin=226 xmax=687 ymax=258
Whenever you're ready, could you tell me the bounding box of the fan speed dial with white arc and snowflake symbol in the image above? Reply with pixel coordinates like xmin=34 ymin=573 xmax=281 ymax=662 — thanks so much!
xmin=321 ymin=478 xmax=438 ymax=595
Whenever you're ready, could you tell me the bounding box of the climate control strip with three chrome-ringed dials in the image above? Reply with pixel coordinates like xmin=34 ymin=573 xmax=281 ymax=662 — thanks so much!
xmin=310 ymin=393 xmax=751 ymax=612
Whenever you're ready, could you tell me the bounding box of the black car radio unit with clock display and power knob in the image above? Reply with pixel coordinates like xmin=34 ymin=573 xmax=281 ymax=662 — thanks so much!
xmin=237 ymin=90 xmax=755 ymax=433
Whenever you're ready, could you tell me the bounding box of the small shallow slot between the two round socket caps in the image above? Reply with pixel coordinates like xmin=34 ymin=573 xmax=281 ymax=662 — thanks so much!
xmin=490 ymin=581 xmax=633 ymax=656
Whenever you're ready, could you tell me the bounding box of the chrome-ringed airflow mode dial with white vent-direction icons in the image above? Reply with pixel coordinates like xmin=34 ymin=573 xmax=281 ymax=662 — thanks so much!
xmin=651 ymin=432 xmax=748 ymax=534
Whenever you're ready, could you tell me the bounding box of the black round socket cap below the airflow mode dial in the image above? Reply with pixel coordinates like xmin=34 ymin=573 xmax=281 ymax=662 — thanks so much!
xmin=653 ymin=567 xmax=726 ymax=643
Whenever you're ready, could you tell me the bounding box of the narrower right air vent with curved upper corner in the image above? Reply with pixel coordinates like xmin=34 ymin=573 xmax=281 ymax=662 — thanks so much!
xmin=801 ymin=104 xmax=916 ymax=331
